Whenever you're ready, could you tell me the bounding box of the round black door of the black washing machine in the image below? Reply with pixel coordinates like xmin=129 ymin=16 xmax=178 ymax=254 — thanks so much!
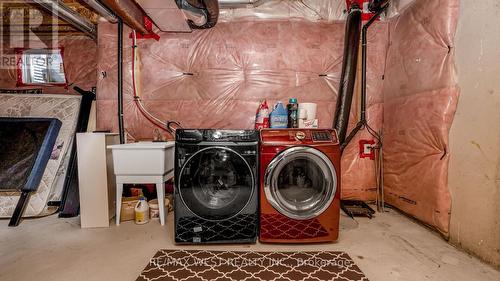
xmin=178 ymin=147 xmax=255 ymax=220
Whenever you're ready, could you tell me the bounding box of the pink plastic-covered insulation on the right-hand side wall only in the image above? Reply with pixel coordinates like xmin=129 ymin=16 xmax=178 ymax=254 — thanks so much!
xmin=383 ymin=0 xmax=459 ymax=235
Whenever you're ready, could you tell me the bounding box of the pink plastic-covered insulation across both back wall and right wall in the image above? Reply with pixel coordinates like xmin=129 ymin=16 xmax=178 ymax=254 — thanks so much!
xmin=97 ymin=0 xmax=459 ymax=235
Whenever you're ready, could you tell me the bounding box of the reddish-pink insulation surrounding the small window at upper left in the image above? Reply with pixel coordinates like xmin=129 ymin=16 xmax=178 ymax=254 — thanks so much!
xmin=0 ymin=37 xmax=97 ymax=94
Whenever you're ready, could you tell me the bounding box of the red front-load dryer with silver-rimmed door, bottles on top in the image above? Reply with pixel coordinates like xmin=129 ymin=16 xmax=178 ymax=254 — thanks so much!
xmin=259 ymin=129 xmax=340 ymax=243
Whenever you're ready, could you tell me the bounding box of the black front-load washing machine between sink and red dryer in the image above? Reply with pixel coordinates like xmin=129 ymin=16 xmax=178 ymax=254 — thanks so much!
xmin=174 ymin=129 xmax=259 ymax=243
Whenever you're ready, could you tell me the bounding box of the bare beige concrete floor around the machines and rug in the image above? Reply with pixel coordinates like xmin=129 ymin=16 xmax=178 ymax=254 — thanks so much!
xmin=0 ymin=211 xmax=500 ymax=281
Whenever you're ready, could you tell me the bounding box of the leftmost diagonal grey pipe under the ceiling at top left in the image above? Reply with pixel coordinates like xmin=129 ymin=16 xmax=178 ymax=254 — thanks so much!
xmin=33 ymin=0 xmax=97 ymax=40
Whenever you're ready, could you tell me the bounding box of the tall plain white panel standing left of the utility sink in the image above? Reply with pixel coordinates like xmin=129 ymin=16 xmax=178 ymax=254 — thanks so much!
xmin=76 ymin=133 xmax=120 ymax=228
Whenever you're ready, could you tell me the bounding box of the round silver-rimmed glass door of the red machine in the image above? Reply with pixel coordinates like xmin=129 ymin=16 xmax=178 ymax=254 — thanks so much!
xmin=264 ymin=147 xmax=337 ymax=220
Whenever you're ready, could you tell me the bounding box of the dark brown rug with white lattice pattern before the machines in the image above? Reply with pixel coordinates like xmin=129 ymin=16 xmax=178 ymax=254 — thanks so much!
xmin=137 ymin=250 xmax=368 ymax=281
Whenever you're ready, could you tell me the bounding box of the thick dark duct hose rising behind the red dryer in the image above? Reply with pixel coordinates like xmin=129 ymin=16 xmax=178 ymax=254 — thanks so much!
xmin=333 ymin=3 xmax=361 ymax=149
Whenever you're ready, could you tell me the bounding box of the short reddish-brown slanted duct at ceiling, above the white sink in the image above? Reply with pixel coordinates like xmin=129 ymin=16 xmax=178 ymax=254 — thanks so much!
xmin=101 ymin=0 xmax=149 ymax=34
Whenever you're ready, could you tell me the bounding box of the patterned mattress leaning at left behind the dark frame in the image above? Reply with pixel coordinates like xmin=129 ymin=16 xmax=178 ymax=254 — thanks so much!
xmin=0 ymin=94 xmax=81 ymax=218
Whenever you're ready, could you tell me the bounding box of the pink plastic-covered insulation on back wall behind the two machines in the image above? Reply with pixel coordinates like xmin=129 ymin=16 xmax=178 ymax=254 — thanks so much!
xmin=97 ymin=19 xmax=388 ymax=200
